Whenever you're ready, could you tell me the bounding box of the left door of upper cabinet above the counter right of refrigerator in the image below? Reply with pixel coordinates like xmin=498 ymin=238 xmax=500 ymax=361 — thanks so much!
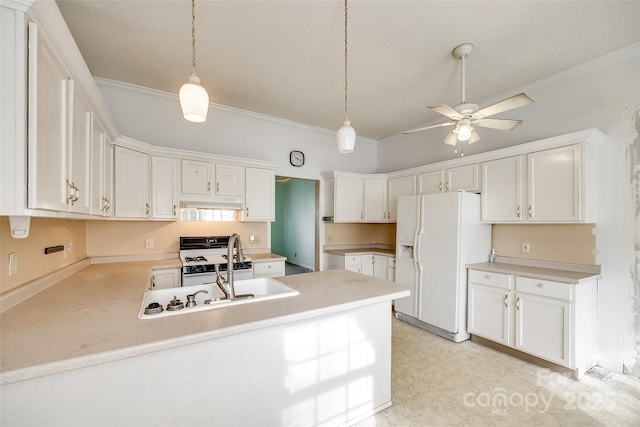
xmin=481 ymin=156 xmax=525 ymax=222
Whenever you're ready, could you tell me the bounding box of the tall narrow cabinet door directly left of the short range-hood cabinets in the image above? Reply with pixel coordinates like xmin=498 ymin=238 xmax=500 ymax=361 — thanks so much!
xmin=151 ymin=157 xmax=178 ymax=219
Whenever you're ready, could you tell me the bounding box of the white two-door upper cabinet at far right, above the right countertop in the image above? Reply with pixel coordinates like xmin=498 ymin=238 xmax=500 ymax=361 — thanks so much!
xmin=482 ymin=144 xmax=595 ymax=223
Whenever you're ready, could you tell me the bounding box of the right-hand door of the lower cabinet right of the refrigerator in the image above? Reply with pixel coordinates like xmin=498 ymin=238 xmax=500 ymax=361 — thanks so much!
xmin=515 ymin=292 xmax=572 ymax=366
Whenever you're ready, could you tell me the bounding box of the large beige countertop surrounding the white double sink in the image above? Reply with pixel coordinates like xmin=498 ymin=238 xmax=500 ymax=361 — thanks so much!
xmin=0 ymin=261 xmax=409 ymax=384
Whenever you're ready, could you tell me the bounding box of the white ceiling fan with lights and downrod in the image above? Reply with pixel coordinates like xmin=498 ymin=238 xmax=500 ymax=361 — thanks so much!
xmin=403 ymin=43 xmax=533 ymax=152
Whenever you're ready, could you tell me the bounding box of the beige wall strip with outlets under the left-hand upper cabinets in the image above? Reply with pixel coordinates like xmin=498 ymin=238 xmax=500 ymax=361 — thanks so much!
xmin=0 ymin=216 xmax=87 ymax=293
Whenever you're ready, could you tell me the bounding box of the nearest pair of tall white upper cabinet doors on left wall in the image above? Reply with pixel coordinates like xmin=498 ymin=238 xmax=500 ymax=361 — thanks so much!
xmin=28 ymin=23 xmax=93 ymax=214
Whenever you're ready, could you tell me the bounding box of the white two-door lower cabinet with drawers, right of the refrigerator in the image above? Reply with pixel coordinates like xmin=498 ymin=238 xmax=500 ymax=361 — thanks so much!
xmin=467 ymin=270 xmax=597 ymax=377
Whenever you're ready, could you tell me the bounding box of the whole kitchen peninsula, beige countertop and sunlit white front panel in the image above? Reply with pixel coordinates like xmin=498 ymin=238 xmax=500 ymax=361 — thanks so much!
xmin=0 ymin=261 xmax=408 ymax=425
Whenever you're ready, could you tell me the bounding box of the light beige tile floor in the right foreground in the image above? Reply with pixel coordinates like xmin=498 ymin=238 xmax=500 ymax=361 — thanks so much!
xmin=358 ymin=319 xmax=640 ymax=427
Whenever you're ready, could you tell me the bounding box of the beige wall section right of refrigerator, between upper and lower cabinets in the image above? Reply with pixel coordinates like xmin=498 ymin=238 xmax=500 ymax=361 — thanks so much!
xmin=491 ymin=224 xmax=596 ymax=264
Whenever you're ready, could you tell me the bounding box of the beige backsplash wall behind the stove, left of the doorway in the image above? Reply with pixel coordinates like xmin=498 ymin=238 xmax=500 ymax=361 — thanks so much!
xmin=87 ymin=221 xmax=270 ymax=257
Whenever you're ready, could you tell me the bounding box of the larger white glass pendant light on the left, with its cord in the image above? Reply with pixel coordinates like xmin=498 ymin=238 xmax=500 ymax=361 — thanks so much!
xmin=180 ymin=0 xmax=209 ymax=122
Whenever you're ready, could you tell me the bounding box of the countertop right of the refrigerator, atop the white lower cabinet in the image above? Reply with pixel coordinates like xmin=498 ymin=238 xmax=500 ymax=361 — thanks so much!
xmin=466 ymin=262 xmax=601 ymax=284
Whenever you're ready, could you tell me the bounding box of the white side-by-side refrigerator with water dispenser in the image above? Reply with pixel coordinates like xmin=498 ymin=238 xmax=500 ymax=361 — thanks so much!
xmin=394 ymin=192 xmax=491 ymax=342
